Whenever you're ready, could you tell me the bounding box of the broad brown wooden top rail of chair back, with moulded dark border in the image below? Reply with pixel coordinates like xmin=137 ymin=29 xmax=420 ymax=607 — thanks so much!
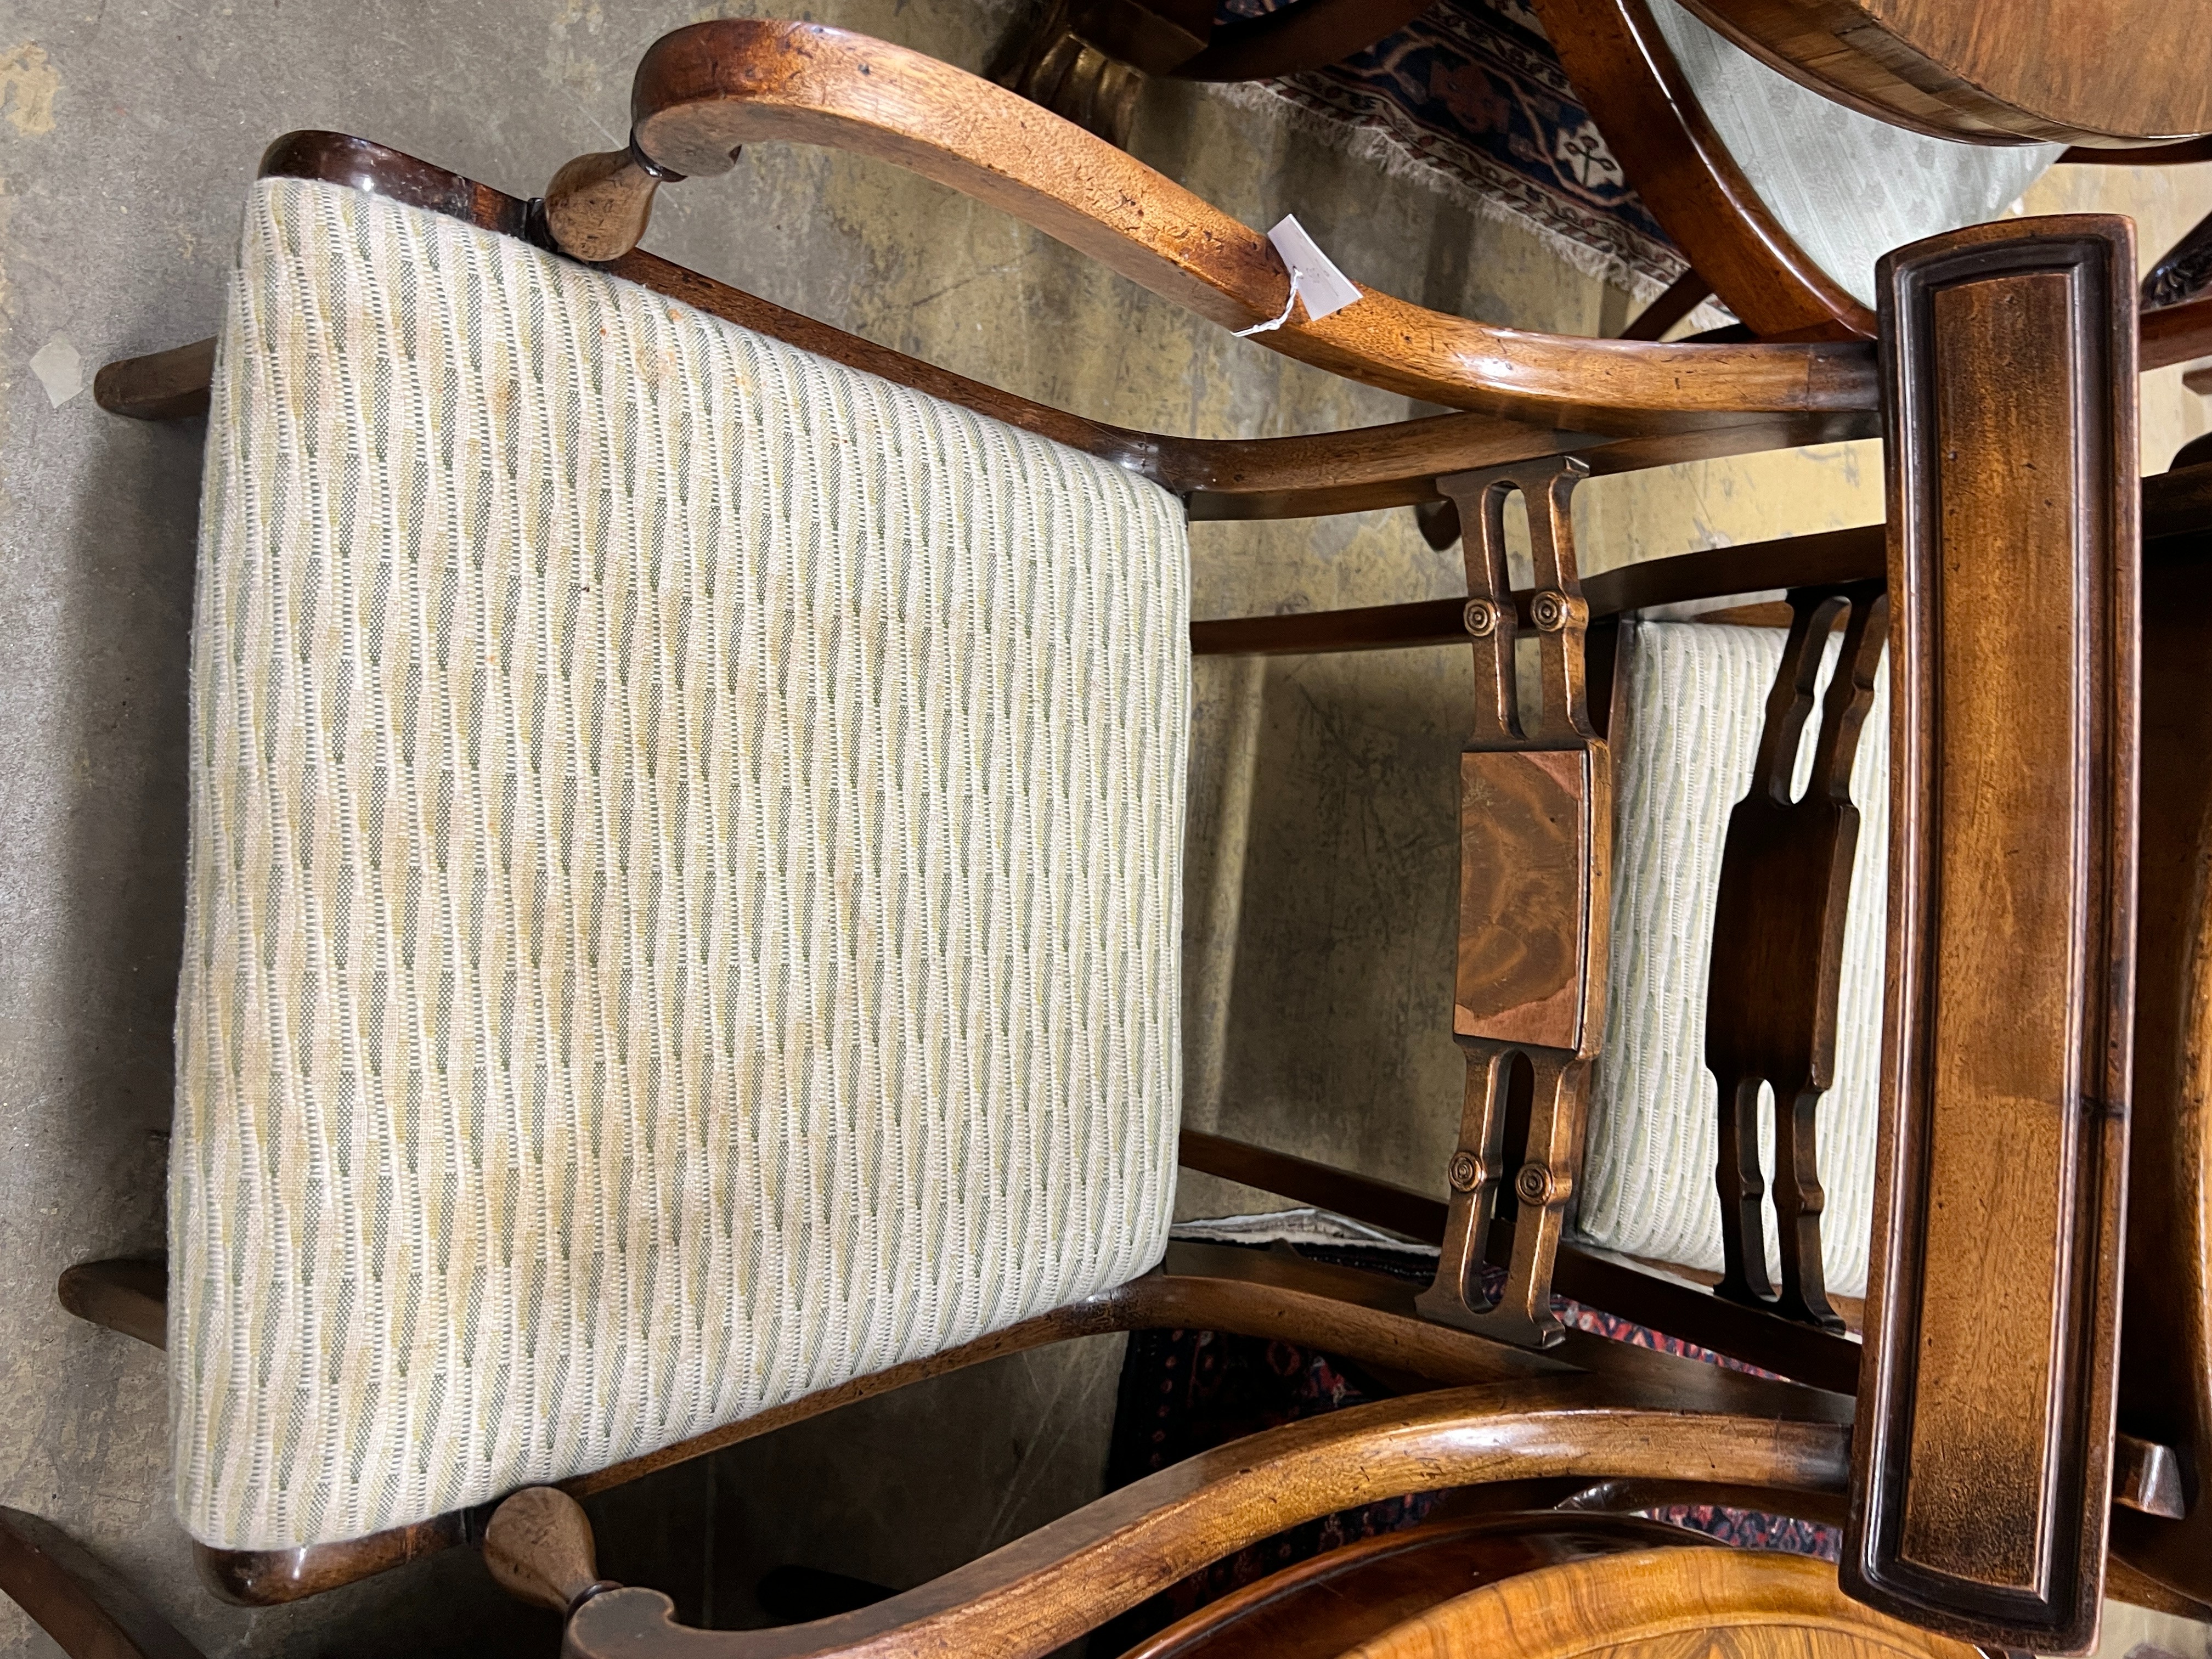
xmin=1843 ymin=215 xmax=2141 ymax=1652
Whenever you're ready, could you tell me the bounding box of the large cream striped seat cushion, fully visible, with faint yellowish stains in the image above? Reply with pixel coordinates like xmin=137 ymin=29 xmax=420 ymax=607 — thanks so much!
xmin=170 ymin=179 xmax=1188 ymax=1548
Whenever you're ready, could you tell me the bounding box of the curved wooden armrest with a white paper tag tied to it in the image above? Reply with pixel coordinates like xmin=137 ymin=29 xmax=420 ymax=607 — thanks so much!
xmin=531 ymin=20 xmax=1876 ymax=433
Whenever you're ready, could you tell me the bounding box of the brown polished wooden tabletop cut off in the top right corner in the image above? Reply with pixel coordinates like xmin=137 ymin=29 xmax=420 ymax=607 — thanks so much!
xmin=1683 ymin=0 xmax=2212 ymax=148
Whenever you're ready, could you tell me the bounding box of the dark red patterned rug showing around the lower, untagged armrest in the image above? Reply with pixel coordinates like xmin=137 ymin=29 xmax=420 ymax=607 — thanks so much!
xmin=1091 ymin=1210 xmax=1841 ymax=1655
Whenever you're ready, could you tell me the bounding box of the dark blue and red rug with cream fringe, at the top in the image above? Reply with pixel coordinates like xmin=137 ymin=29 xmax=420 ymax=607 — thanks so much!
xmin=1217 ymin=0 xmax=1732 ymax=312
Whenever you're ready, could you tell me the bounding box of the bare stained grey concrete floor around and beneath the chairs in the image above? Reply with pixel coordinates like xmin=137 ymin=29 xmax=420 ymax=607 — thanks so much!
xmin=0 ymin=0 xmax=2212 ymax=1659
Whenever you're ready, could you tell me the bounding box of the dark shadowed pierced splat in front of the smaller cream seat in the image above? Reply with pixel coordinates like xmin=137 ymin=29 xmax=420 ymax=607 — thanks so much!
xmin=1706 ymin=582 xmax=1889 ymax=1329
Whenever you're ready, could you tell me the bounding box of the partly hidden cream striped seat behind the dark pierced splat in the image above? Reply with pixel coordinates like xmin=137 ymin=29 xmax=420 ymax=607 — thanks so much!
xmin=1575 ymin=622 xmax=1889 ymax=1296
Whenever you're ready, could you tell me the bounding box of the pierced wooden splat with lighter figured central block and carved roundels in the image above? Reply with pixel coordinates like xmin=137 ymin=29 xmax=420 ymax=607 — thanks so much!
xmin=1418 ymin=458 xmax=1612 ymax=1347
